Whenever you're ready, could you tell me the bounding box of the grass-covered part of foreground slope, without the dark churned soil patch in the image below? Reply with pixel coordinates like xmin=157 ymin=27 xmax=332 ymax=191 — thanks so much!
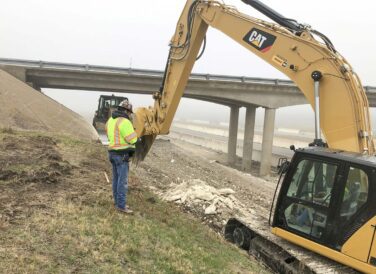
xmin=0 ymin=131 xmax=266 ymax=273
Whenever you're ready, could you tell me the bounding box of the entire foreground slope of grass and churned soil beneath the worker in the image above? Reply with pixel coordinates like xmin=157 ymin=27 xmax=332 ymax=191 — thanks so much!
xmin=0 ymin=129 xmax=269 ymax=273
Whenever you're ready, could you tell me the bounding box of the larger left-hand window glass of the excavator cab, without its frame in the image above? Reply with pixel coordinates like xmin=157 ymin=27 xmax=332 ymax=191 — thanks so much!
xmin=284 ymin=159 xmax=337 ymax=239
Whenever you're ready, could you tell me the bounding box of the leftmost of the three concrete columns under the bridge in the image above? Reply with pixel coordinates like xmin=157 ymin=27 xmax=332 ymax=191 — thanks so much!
xmin=227 ymin=106 xmax=239 ymax=165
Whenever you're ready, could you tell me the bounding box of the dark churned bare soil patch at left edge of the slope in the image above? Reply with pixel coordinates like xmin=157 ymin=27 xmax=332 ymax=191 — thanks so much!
xmin=0 ymin=130 xmax=74 ymax=225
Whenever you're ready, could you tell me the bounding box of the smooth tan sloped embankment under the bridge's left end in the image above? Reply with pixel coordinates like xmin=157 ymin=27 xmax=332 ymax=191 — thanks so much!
xmin=0 ymin=70 xmax=98 ymax=140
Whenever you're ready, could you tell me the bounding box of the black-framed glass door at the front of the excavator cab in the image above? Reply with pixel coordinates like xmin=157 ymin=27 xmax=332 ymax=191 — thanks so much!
xmin=273 ymin=156 xmax=342 ymax=245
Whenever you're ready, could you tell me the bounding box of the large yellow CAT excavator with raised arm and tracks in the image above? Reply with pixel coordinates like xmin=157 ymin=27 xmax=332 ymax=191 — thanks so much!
xmin=134 ymin=0 xmax=376 ymax=273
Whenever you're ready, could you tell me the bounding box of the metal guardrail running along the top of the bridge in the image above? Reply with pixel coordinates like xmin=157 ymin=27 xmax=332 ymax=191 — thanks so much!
xmin=0 ymin=58 xmax=295 ymax=86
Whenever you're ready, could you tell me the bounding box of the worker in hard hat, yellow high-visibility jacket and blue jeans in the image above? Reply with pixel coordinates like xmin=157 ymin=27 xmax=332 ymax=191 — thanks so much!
xmin=106 ymin=99 xmax=137 ymax=214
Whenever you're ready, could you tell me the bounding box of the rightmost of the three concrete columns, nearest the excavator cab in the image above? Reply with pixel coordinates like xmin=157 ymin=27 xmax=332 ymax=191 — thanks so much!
xmin=260 ymin=108 xmax=276 ymax=176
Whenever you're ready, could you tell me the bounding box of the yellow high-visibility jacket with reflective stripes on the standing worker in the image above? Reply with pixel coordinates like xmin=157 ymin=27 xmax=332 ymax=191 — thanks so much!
xmin=106 ymin=117 xmax=137 ymax=150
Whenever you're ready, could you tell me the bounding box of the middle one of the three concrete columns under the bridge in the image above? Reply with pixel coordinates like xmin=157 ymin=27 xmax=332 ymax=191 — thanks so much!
xmin=242 ymin=105 xmax=256 ymax=171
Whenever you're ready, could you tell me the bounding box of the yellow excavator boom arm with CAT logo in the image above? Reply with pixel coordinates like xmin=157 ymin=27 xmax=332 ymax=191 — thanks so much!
xmin=135 ymin=0 xmax=374 ymax=158
